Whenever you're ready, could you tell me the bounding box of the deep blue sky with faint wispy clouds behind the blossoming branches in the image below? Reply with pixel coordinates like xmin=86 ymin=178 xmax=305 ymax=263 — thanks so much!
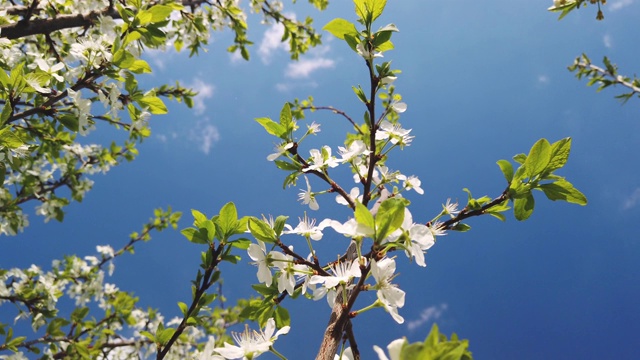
xmin=0 ymin=0 xmax=640 ymax=359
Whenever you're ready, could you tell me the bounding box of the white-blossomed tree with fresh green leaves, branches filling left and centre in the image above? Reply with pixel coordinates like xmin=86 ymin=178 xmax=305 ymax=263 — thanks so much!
xmin=0 ymin=0 xmax=587 ymax=359
